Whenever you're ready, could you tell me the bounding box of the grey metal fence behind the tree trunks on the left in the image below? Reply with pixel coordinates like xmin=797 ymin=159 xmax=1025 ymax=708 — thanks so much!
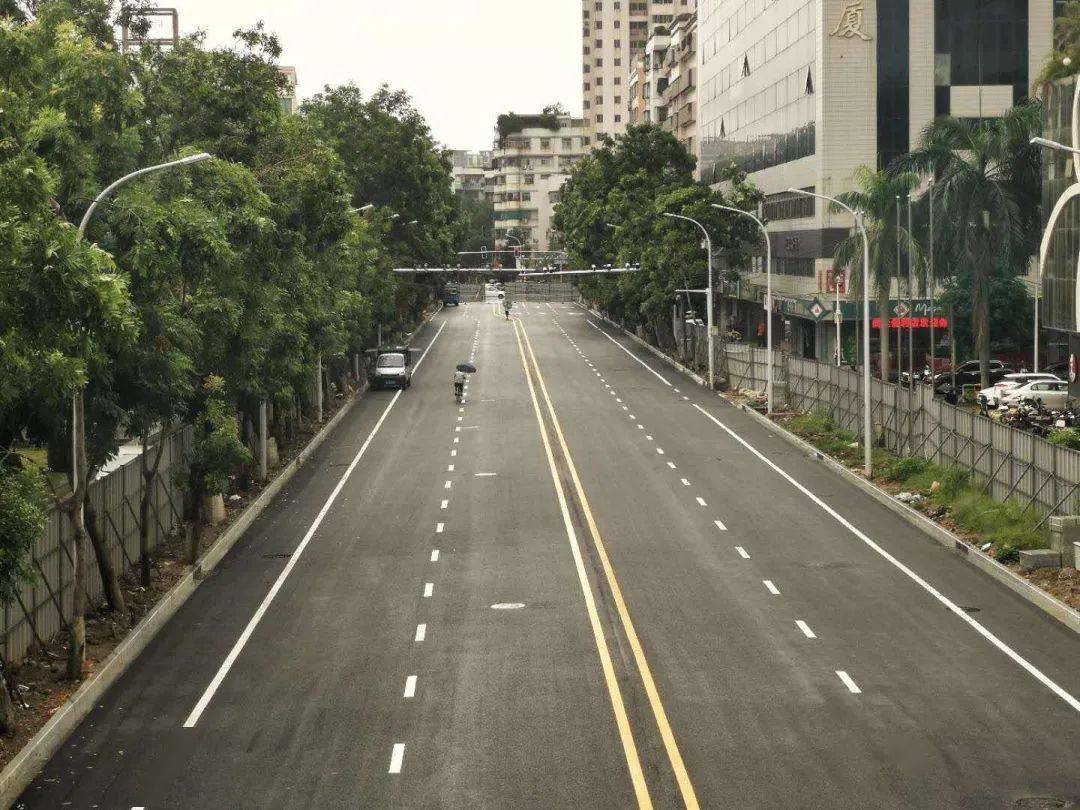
xmin=3 ymin=427 xmax=192 ymax=662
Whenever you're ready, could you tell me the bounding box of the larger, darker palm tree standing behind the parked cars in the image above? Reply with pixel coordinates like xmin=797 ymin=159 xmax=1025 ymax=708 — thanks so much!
xmin=890 ymin=105 xmax=1041 ymax=388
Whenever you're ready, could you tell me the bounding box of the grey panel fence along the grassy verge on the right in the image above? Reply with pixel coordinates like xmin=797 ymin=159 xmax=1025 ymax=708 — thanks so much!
xmin=778 ymin=357 xmax=1080 ymax=515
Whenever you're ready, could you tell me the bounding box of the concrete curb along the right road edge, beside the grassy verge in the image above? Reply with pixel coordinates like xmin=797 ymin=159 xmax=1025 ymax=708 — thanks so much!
xmin=585 ymin=307 xmax=1080 ymax=633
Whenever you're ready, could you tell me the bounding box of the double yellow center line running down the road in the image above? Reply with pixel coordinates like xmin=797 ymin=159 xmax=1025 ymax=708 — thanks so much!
xmin=514 ymin=319 xmax=698 ymax=809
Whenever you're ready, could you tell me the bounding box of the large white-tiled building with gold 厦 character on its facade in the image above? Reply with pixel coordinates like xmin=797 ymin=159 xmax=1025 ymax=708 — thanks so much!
xmin=697 ymin=0 xmax=1053 ymax=359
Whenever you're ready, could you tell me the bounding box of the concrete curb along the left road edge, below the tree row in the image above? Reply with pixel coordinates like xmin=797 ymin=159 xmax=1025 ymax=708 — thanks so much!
xmin=0 ymin=307 xmax=442 ymax=807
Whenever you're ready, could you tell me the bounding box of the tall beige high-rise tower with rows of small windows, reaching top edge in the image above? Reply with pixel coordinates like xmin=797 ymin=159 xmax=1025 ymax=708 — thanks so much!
xmin=581 ymin=0 xmax=694 ymax=135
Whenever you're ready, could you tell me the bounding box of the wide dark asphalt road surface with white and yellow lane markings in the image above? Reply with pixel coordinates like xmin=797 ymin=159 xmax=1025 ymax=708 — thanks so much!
xmin=22 ymin=301 xmax=1080 ymax=810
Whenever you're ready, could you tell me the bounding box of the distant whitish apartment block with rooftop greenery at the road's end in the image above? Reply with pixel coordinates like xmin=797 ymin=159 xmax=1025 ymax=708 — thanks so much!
xmin=485 ymin=114 xmax=591 ymax=251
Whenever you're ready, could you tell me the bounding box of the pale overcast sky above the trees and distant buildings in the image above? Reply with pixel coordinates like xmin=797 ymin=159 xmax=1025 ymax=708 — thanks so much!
xmin=170 ymin=0 xmax=581 ymax=149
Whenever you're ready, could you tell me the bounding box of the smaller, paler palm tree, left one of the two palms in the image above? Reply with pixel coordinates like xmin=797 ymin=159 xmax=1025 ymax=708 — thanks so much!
xmin=833 ymin=166 xmax=921 ymax=380
